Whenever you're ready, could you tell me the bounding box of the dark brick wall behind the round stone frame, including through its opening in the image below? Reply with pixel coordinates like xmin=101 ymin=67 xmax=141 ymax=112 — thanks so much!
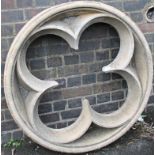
xmin=1 ymin=0 xmax=154 ymax=143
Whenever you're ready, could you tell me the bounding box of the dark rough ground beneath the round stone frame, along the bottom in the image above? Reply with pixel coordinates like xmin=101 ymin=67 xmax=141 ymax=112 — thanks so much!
xmin=2 ymin=112 xmax=154 ymax=155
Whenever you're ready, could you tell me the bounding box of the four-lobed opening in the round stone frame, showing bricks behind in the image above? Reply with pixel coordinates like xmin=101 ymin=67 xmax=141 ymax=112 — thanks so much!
xmin=27 ymin=23 xmax=127 ymax=128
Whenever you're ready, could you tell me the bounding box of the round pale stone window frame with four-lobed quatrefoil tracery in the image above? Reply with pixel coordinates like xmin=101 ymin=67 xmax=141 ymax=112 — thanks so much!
xmin=4 ymin=1 xmax=153 ymax=153
